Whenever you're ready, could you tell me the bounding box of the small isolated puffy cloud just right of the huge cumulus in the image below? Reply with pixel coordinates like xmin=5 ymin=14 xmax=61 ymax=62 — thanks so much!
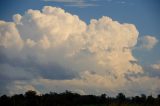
xmin=139 ymin=35 xmax=158 ymax=50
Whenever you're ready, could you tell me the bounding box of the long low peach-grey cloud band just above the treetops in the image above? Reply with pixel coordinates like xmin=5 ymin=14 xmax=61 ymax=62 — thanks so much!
xmin=5 ymin=71 xmax=160 ymax=96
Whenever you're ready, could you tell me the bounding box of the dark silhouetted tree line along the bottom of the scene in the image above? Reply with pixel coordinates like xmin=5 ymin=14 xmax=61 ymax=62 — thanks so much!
xmin=0 ymin=91 xmax=160 ymax=106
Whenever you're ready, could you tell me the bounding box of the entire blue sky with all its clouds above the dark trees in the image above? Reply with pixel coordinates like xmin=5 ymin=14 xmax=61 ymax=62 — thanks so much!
xmin=0 ymin=0 xmax=160 ymax=96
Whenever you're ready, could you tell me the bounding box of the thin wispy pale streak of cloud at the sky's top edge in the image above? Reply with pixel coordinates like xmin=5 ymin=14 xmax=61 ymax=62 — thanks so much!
xmin=43 ymin=0 xmax=98 ymax=8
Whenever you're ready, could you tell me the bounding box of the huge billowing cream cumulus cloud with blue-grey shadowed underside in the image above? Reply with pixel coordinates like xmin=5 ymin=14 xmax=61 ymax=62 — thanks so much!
xmin=0 ymin=6 xmax=159 ymax=95
